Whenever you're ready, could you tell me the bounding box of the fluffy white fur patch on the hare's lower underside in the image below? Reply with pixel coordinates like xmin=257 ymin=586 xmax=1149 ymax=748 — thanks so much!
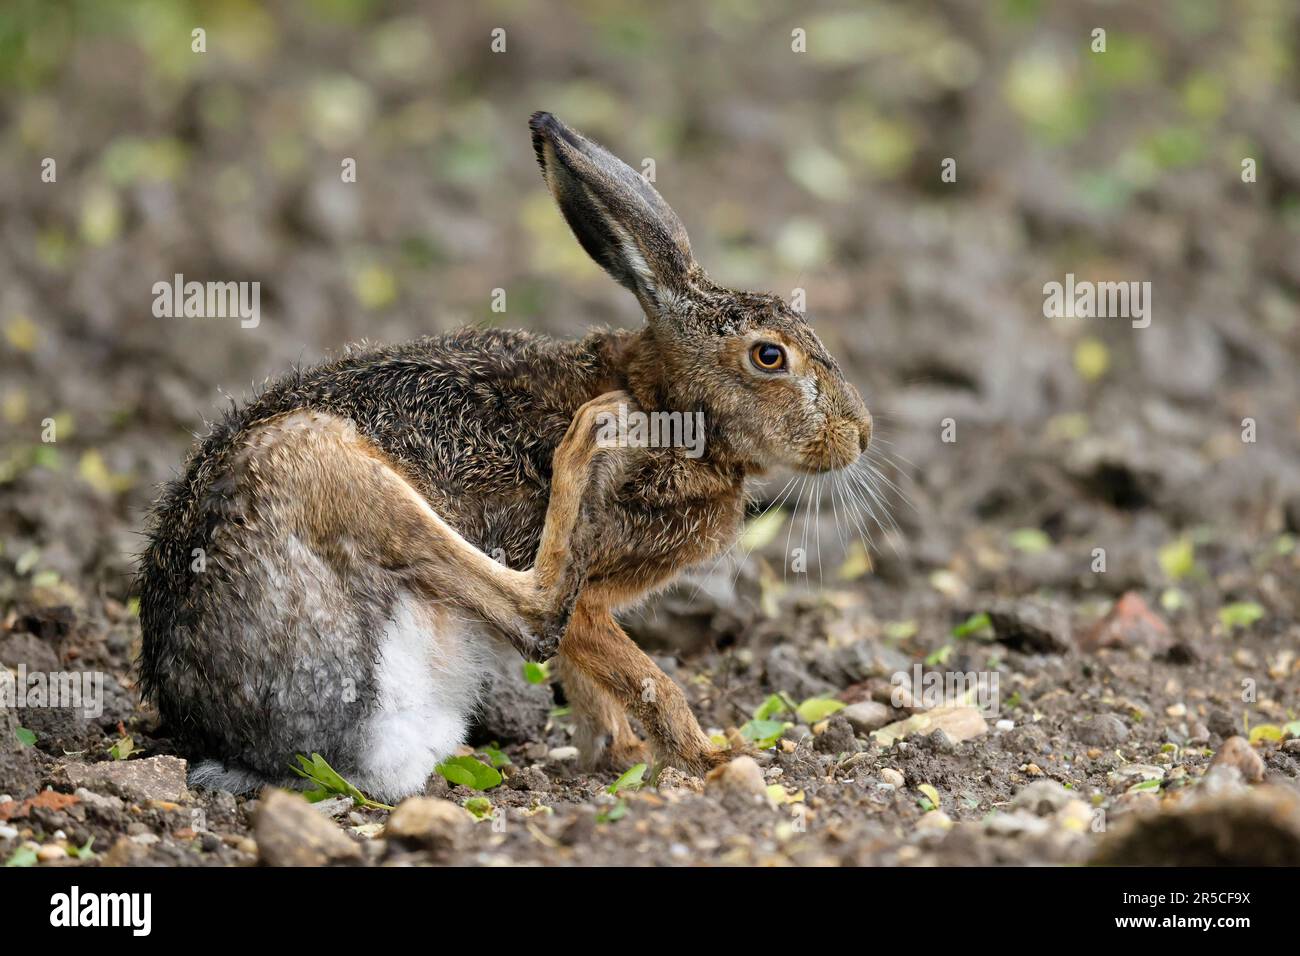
xmin=356 ymin=594 xmax=498 ymax=796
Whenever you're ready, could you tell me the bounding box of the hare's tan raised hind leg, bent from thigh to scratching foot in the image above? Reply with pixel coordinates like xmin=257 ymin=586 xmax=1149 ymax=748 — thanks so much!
xmin=237 ymin=393 xmax=628 ymax=659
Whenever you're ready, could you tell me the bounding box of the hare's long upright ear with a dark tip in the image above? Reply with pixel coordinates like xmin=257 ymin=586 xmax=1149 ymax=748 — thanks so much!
xmin=528 ymin=113 xmax=696 ymax=319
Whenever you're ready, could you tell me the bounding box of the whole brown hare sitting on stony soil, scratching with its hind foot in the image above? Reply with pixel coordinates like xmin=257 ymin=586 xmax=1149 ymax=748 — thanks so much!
xmin=139 ymin=113 xmax=871 ymax=799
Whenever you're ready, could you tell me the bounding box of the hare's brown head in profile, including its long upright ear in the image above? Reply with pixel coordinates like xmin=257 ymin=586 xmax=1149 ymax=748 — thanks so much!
xmin=529 ymin=113 xmax=871 ymax=471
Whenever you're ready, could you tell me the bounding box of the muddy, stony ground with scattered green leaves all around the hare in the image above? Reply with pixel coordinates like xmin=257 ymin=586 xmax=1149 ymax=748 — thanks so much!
xmin=0 ymin=3 xmax=1300 ymax=866
